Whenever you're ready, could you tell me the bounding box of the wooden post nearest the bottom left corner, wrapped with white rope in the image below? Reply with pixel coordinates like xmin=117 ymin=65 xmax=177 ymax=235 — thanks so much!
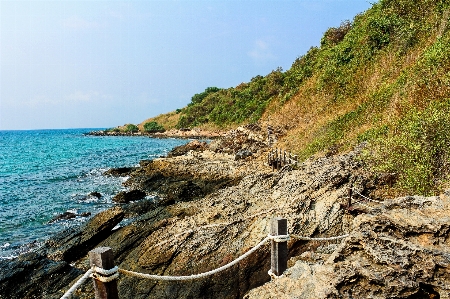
xmin=89 ymin=247 xmax=119 ymax=299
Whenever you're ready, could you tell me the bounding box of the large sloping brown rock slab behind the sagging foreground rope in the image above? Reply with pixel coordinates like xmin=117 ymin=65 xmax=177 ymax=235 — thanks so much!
xmin=62 ymin=148 xmax=372 ymax=299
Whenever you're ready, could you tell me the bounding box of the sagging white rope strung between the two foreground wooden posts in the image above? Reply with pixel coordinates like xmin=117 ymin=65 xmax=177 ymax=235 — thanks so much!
xmin=119 ymin=236 xmax=271 ymax=281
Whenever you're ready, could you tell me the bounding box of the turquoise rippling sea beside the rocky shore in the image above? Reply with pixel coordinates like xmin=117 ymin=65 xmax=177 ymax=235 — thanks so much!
xmin=0 ymin=129 xmax=187 ymax=259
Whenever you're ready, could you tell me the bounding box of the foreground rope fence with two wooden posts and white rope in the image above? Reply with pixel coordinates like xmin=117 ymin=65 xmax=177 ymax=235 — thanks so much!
xmin=61 ymin=218 xmax=349 ymax=299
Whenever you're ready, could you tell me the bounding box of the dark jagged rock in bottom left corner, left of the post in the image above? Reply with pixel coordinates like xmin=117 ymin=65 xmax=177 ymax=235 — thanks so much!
xmin=0 ymin=252 xmax=83 ymax=299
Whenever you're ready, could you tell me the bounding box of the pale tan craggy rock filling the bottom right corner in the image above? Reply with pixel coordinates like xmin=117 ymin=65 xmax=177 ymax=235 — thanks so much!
xmin=245 ymin=195 xmax=450 ymax=299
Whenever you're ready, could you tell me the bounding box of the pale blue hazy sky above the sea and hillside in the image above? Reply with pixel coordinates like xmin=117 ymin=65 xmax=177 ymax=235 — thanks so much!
xmin=0 ymin=0 xmax=373 ymax=130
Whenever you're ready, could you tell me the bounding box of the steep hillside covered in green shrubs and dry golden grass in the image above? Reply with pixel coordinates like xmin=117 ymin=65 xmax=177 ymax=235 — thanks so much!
xmin=139 ymin=0 xmax=450 ymax=195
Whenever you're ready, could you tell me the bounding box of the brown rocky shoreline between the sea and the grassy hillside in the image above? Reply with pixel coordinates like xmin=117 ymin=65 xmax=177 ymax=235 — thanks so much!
xmin=0 ymin=126 xmax=450 ymax=299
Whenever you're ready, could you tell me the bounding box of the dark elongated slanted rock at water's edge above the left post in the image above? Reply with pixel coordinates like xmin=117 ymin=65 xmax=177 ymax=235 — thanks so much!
xmin=40 ymin=207 xmax=124 ymax=263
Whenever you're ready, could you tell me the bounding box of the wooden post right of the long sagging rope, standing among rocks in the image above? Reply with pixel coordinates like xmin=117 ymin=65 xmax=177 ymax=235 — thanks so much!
xmin=270 ymin=217 xmax=288 ymax=276
